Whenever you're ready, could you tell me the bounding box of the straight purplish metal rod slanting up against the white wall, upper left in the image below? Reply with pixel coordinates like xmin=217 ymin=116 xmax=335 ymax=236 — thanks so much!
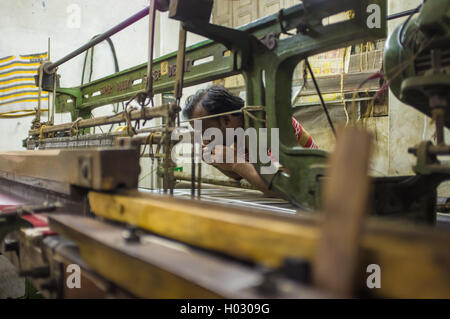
xmin=44 ymin=7 xmax=149 ymax=74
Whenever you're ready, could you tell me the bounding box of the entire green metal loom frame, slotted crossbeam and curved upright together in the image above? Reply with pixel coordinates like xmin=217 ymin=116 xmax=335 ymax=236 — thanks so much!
xmin=41 ymin=0 xmax=386 ymax=209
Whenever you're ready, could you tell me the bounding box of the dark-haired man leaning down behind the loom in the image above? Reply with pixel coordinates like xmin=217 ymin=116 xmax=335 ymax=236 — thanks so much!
xmin=183 ymin=86 xmax=318 ymax=196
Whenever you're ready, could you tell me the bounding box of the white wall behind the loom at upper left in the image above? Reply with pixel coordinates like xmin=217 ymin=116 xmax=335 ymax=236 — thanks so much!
xmin=0 ymin=0 xmax=148 ymax=150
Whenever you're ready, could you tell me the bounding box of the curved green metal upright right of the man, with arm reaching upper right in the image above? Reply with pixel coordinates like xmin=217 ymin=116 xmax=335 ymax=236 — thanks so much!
xmin=244 ymin=1 xmax=386 ymax=209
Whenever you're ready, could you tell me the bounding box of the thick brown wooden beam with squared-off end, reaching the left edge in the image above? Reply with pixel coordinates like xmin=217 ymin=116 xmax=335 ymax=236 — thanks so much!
xmin=0 ymin=148 xmax=140 ymax=190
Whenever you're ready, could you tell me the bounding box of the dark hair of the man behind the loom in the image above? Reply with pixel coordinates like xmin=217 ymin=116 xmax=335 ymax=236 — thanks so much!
xmin=183 ymin=85 xmax=245 ymax=119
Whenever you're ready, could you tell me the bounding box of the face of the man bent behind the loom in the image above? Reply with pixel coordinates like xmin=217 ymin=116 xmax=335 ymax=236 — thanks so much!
xmin=191 ymin=103 xmax=244 ymax=145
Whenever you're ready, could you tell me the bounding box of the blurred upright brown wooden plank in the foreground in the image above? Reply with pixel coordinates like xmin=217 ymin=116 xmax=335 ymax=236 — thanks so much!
xmin=314 ymin=127 xmax=371 ymax=297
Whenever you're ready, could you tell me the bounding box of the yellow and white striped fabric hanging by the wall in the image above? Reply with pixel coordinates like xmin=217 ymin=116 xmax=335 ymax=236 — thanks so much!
xmin=0 ymin=53 xmax=48 ymax=116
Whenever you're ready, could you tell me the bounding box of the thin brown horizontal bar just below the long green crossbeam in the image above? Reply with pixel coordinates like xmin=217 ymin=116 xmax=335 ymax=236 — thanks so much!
xmin=29 ymin=104 xmax=174 ymax=136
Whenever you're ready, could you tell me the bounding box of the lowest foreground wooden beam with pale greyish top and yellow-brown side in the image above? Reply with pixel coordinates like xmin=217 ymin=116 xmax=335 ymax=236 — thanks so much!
xmin=49 ymin=215 xmax=329 ymax=298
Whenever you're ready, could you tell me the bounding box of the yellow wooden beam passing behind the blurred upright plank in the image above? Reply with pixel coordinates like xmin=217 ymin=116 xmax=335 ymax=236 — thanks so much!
xmin=89 ymin=189 xmax=450 ymax=298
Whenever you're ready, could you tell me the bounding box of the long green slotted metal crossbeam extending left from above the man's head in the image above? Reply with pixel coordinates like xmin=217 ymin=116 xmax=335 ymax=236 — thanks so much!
xmin=46 ymin=41 xmax=238 ymax=120
